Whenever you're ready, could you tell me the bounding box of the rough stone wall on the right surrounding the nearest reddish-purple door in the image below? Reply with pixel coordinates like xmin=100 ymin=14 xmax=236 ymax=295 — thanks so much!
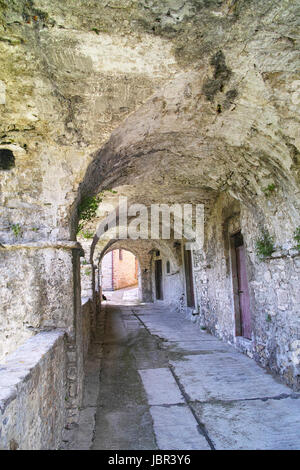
xmin=194 ymin=195 xmax=300 ymax=388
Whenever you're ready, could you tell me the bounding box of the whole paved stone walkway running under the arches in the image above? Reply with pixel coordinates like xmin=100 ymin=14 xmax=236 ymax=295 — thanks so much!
xmin=67 ymin=303 xmax=300 ymax=450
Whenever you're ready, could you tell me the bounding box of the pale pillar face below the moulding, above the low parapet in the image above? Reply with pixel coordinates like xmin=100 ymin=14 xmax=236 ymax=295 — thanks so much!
xmin=0 ymin=246 xmax=74 ymax=360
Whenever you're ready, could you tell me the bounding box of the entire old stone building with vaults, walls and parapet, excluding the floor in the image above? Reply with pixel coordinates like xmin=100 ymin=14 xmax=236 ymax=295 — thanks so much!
xmin=0 ymin=0 xmax=300 ymax=449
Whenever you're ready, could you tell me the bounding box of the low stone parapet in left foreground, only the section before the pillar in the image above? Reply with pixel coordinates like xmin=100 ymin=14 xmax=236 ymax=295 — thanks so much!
xmin=0 ymin=330 xmax=67 ymax=450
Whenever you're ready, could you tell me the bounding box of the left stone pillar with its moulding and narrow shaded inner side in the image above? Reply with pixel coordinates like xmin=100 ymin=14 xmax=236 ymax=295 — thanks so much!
xmin=0 ymin=242 xmax=88 ymax=425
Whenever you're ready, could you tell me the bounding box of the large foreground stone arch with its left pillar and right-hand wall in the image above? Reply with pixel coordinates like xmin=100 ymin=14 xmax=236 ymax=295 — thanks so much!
xmin=0 ymin=0 xmax=300 ymax=446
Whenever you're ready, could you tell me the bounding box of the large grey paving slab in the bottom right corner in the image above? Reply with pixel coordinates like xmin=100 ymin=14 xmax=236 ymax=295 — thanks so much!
xmin=192 ymin=398 xmax=300 ymax=450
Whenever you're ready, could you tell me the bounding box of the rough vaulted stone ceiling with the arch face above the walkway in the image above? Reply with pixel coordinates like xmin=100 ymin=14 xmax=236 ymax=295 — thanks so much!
xmin=0 ymin=0 xmax=300 ymax=248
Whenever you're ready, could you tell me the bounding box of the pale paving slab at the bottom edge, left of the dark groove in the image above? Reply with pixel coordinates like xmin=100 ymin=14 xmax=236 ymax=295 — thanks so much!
xmin=150 ymin=406 xmax=210 ymax=450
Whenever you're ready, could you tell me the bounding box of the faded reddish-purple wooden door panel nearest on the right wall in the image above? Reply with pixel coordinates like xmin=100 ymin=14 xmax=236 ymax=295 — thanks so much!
xmin=236 ymin=245 xmax=251 ymax=339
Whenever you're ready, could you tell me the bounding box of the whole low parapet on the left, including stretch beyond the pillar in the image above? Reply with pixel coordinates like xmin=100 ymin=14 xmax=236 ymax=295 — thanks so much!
xmin=0 ymin=299 xmax=94 ymax=449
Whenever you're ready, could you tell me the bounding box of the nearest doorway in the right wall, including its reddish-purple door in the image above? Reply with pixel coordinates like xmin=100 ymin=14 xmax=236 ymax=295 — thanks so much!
xmin=232 ymin=232 xmax=252 ymax=339
